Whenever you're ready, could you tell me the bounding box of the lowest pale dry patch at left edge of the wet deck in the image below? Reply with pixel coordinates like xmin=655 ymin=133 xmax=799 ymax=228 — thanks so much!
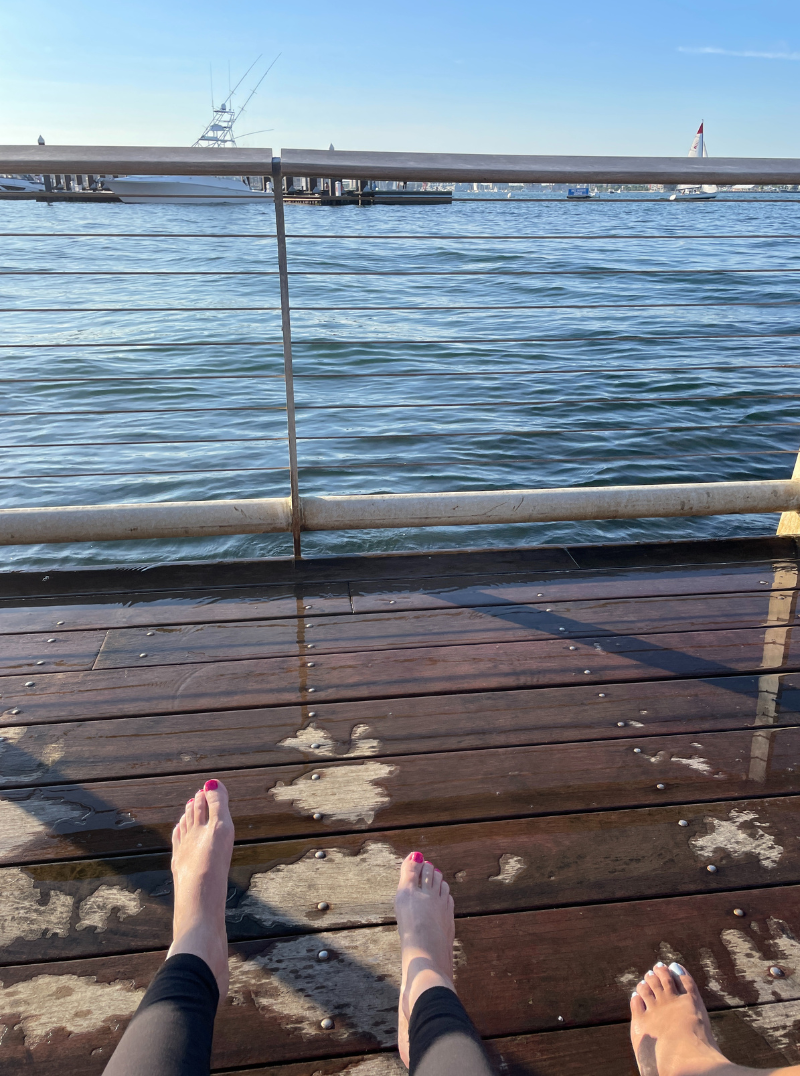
xmin=0 ymin=975 xmax=144 ymax=1056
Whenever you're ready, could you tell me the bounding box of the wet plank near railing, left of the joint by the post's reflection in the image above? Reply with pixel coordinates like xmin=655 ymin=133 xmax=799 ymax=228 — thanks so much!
xmin=0 ymin=583 xmax=351 ymax=635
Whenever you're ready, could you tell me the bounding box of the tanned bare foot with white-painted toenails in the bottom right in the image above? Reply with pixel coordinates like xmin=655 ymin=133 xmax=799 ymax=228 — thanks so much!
xmin=631 ymin=963 xmax=736 ymax=1076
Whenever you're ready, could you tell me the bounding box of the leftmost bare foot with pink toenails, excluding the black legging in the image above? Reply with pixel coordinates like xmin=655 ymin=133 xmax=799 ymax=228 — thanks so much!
xmin=167 ymin=780 xmax=234 ymax=1000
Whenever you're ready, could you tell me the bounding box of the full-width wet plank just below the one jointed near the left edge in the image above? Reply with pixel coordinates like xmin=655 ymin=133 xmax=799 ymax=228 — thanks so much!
xmin=0 ymin=627 xmax=800 ymax=724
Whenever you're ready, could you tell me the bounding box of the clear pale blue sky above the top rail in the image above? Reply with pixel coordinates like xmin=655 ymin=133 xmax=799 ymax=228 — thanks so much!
xmin=0 ymin=0 xmax=800 ymax=156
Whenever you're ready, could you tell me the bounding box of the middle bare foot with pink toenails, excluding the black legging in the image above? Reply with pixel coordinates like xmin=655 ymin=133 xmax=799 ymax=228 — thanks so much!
xmin=394 ymin=852 xmax=455 ymax=1067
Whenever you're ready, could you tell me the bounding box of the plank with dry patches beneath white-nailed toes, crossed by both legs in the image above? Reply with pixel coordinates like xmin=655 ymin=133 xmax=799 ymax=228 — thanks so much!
xmin=0 ymin=887 xmax=800 ymax=1076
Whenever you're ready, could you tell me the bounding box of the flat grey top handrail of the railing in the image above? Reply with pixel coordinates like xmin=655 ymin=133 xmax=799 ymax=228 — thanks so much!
xmin=0 ymin=145 xmax=800 ymax=188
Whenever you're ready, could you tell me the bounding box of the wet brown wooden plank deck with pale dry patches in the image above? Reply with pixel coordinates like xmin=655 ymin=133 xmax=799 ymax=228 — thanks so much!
xmin=0 ymin=539 xmax=800 ymax=1076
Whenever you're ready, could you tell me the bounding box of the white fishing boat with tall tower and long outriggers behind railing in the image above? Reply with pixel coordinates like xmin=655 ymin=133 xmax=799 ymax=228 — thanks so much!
xmin=107 ymin=54 xmax=280 ymax=206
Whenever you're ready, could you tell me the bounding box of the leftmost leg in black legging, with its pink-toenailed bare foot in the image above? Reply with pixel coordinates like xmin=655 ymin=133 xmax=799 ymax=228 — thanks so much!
xmin=104 ymin=780 xmax=234 ymax=1076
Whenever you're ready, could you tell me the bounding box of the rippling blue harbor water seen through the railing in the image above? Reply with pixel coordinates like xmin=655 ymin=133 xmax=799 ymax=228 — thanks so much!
xmin=0 ymin=195 xmax=800 ymax=568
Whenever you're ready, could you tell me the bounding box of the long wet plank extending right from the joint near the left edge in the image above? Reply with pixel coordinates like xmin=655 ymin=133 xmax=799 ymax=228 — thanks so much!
xmin=90 ymin=589 xmax=797 ymax=669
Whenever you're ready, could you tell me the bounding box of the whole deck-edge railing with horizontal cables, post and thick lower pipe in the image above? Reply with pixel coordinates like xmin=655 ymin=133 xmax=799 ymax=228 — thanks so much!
xmin=0 ymin=146 xmax=800 ymax=556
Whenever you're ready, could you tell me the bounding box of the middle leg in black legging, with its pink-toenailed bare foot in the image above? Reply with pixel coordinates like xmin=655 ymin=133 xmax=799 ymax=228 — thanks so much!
xmin=395 ymin=852 xmax=491 ymax=1076
